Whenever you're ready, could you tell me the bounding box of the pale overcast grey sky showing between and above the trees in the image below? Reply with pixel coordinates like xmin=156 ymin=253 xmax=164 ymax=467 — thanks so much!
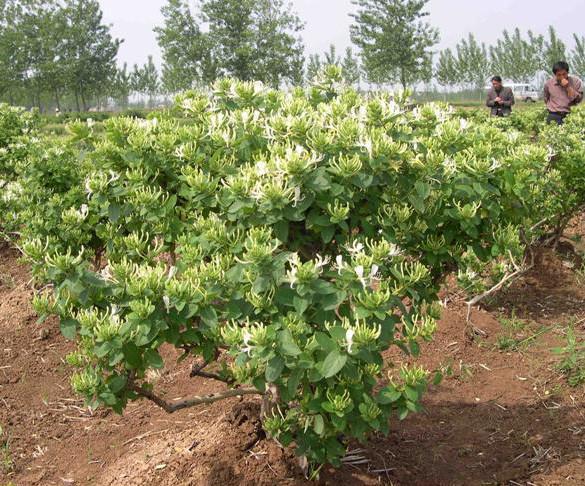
xmin=100 ymin=0 xmax=585 ymax=64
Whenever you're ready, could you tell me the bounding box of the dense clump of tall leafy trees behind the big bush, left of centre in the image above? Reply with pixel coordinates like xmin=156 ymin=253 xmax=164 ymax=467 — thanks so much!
xmin=155 ymin=0 xmax=304 ymax=91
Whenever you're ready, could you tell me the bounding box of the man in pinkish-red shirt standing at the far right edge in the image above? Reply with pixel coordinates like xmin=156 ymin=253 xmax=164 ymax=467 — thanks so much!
xmin=544 ymin=61 xmax=583 ymax=125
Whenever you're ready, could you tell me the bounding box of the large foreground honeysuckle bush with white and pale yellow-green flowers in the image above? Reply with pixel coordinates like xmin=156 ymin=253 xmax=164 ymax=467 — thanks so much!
xmin=2 ymin=68 xmax=575 ymax=464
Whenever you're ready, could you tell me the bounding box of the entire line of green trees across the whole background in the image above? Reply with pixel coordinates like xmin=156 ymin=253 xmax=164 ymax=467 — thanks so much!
xmin=0 ymin=0 xmax=585 ymax=110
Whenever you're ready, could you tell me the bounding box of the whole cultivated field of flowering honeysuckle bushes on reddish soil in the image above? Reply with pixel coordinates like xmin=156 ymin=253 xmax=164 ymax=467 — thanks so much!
xmin=0 ymin=73 xmax=585 ymax=486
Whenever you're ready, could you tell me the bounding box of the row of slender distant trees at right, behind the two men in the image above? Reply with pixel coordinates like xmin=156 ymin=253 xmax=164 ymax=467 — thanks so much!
xmin=435 ymin=26 xmax=585 ymax=88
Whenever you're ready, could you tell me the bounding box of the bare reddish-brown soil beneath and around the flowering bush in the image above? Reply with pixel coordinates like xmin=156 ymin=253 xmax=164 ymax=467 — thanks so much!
xmin=0 ymin=218 xmax=585 ymax=486
